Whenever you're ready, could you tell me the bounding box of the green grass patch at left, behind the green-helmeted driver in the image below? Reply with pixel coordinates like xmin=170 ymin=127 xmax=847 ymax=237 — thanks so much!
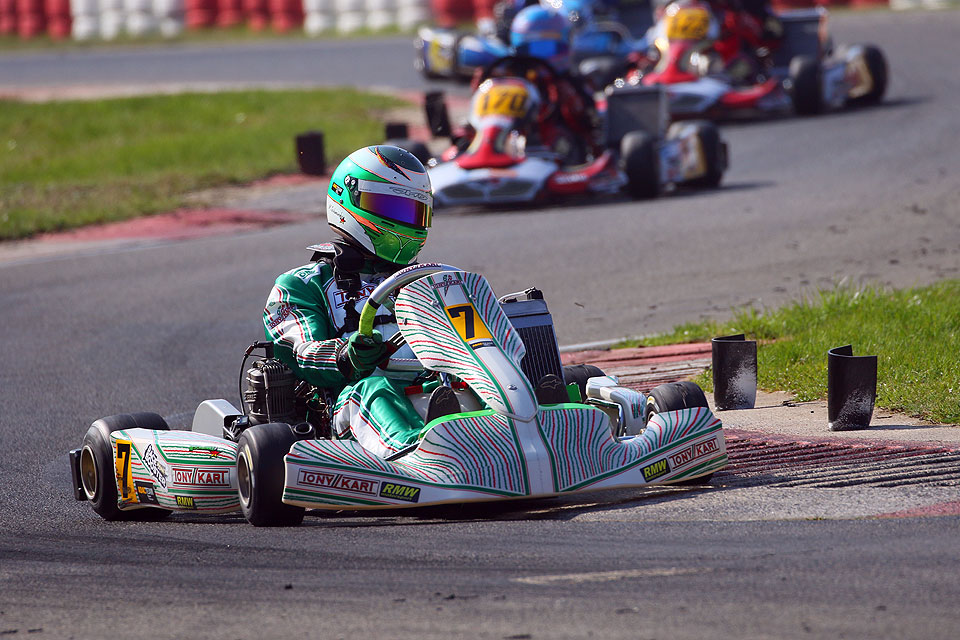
xmin=0 ymin=89 xmax=401 ymax=240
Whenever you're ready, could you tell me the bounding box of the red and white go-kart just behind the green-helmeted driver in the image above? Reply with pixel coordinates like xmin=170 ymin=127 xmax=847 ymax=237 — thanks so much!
xmin=398 ymin=56 xmax=728 ymax=209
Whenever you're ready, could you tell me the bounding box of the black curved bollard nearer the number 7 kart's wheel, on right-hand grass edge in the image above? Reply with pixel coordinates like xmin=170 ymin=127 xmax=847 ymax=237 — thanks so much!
xmin=710 ymin=333 xmax=757 ymax=409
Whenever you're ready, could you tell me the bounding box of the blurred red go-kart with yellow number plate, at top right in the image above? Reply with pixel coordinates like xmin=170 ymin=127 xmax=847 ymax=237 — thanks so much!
xmin=626 ymin=0 xmax=887 ymax=119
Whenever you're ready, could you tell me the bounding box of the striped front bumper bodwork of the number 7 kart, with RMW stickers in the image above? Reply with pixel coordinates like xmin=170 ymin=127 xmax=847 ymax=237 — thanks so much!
xmin=284 ymin=404 xmax=727 ymax=508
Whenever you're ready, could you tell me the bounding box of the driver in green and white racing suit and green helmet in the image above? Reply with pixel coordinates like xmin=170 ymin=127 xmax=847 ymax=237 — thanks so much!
xmin=263 ymin=145 xmax=460 ymax=457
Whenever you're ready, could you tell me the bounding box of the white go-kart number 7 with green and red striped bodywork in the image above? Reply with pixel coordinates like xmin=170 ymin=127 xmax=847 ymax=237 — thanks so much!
xmin=70 ymin=263 xmax=727 ymax=526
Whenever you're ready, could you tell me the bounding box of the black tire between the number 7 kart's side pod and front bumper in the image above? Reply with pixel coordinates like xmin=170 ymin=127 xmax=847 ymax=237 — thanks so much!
xmin=237 ymin=422 xmax=304 ymax=527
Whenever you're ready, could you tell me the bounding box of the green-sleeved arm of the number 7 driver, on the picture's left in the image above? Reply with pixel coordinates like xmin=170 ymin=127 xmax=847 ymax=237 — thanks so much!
xmin=263 ymin=271 xmax=347 ymax=388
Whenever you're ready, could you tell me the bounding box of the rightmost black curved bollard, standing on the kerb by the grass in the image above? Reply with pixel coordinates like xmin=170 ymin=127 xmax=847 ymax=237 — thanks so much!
xmin=827 ymin=344 xmax=877 ymax=431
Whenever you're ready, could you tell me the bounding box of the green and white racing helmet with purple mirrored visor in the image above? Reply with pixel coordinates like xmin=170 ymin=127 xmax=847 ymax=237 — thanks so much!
xmin=327 ymin=145 xmax=433 ymax=265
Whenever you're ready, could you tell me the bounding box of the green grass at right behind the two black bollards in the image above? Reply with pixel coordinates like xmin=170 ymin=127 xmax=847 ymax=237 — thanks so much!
xmin=618 ymin=280 xmax=960 ymax=424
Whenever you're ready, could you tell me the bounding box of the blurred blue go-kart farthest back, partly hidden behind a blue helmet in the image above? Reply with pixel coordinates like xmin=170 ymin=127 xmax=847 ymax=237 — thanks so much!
xmin=413 ymin=0 xmax=653 ymax=88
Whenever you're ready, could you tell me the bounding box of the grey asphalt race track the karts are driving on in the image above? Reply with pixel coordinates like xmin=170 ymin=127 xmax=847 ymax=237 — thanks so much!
xmin=0 ymin=11 xmax=960 ymax=639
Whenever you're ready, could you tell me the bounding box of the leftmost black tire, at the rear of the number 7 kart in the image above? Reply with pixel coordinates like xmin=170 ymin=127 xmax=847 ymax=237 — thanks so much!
xmin=80 ymin=412 xmax=171 ymax=521
